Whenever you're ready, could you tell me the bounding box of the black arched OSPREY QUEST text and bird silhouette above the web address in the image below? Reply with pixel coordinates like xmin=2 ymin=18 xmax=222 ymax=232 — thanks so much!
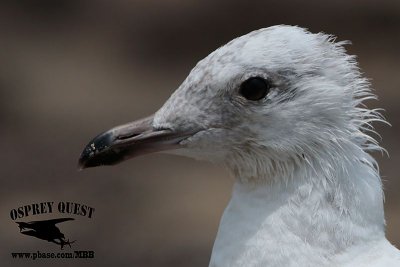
xmin=10 ymin=201 xmax=95 ymax=249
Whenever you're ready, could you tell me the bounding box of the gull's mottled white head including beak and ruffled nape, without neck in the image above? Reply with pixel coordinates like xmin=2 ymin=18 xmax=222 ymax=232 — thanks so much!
xmin=79 ymin=25 xmax=381 ymax=183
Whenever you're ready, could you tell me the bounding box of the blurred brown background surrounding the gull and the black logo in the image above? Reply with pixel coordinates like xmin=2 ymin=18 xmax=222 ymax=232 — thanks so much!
xmin=0 ymin=0 xmax=400 ymax=267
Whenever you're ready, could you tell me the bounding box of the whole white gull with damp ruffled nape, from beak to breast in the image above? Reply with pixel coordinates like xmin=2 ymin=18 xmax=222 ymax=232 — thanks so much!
xmin=79 ymin=25 xmax=400 ymax=267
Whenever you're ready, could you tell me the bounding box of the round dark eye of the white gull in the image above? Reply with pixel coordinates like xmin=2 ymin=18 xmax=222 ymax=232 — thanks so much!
xmin=239 ymin=77 xmax=271 ymax=101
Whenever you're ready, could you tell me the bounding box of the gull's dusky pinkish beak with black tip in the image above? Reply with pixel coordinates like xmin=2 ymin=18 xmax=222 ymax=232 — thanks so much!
xmin=79 ymin=116 xmax=194 ymax=169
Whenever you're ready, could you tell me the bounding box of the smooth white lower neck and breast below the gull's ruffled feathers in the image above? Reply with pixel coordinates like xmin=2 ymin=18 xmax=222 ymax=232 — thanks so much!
xmin=210 ymin=175 xmax=400 ymax=267
